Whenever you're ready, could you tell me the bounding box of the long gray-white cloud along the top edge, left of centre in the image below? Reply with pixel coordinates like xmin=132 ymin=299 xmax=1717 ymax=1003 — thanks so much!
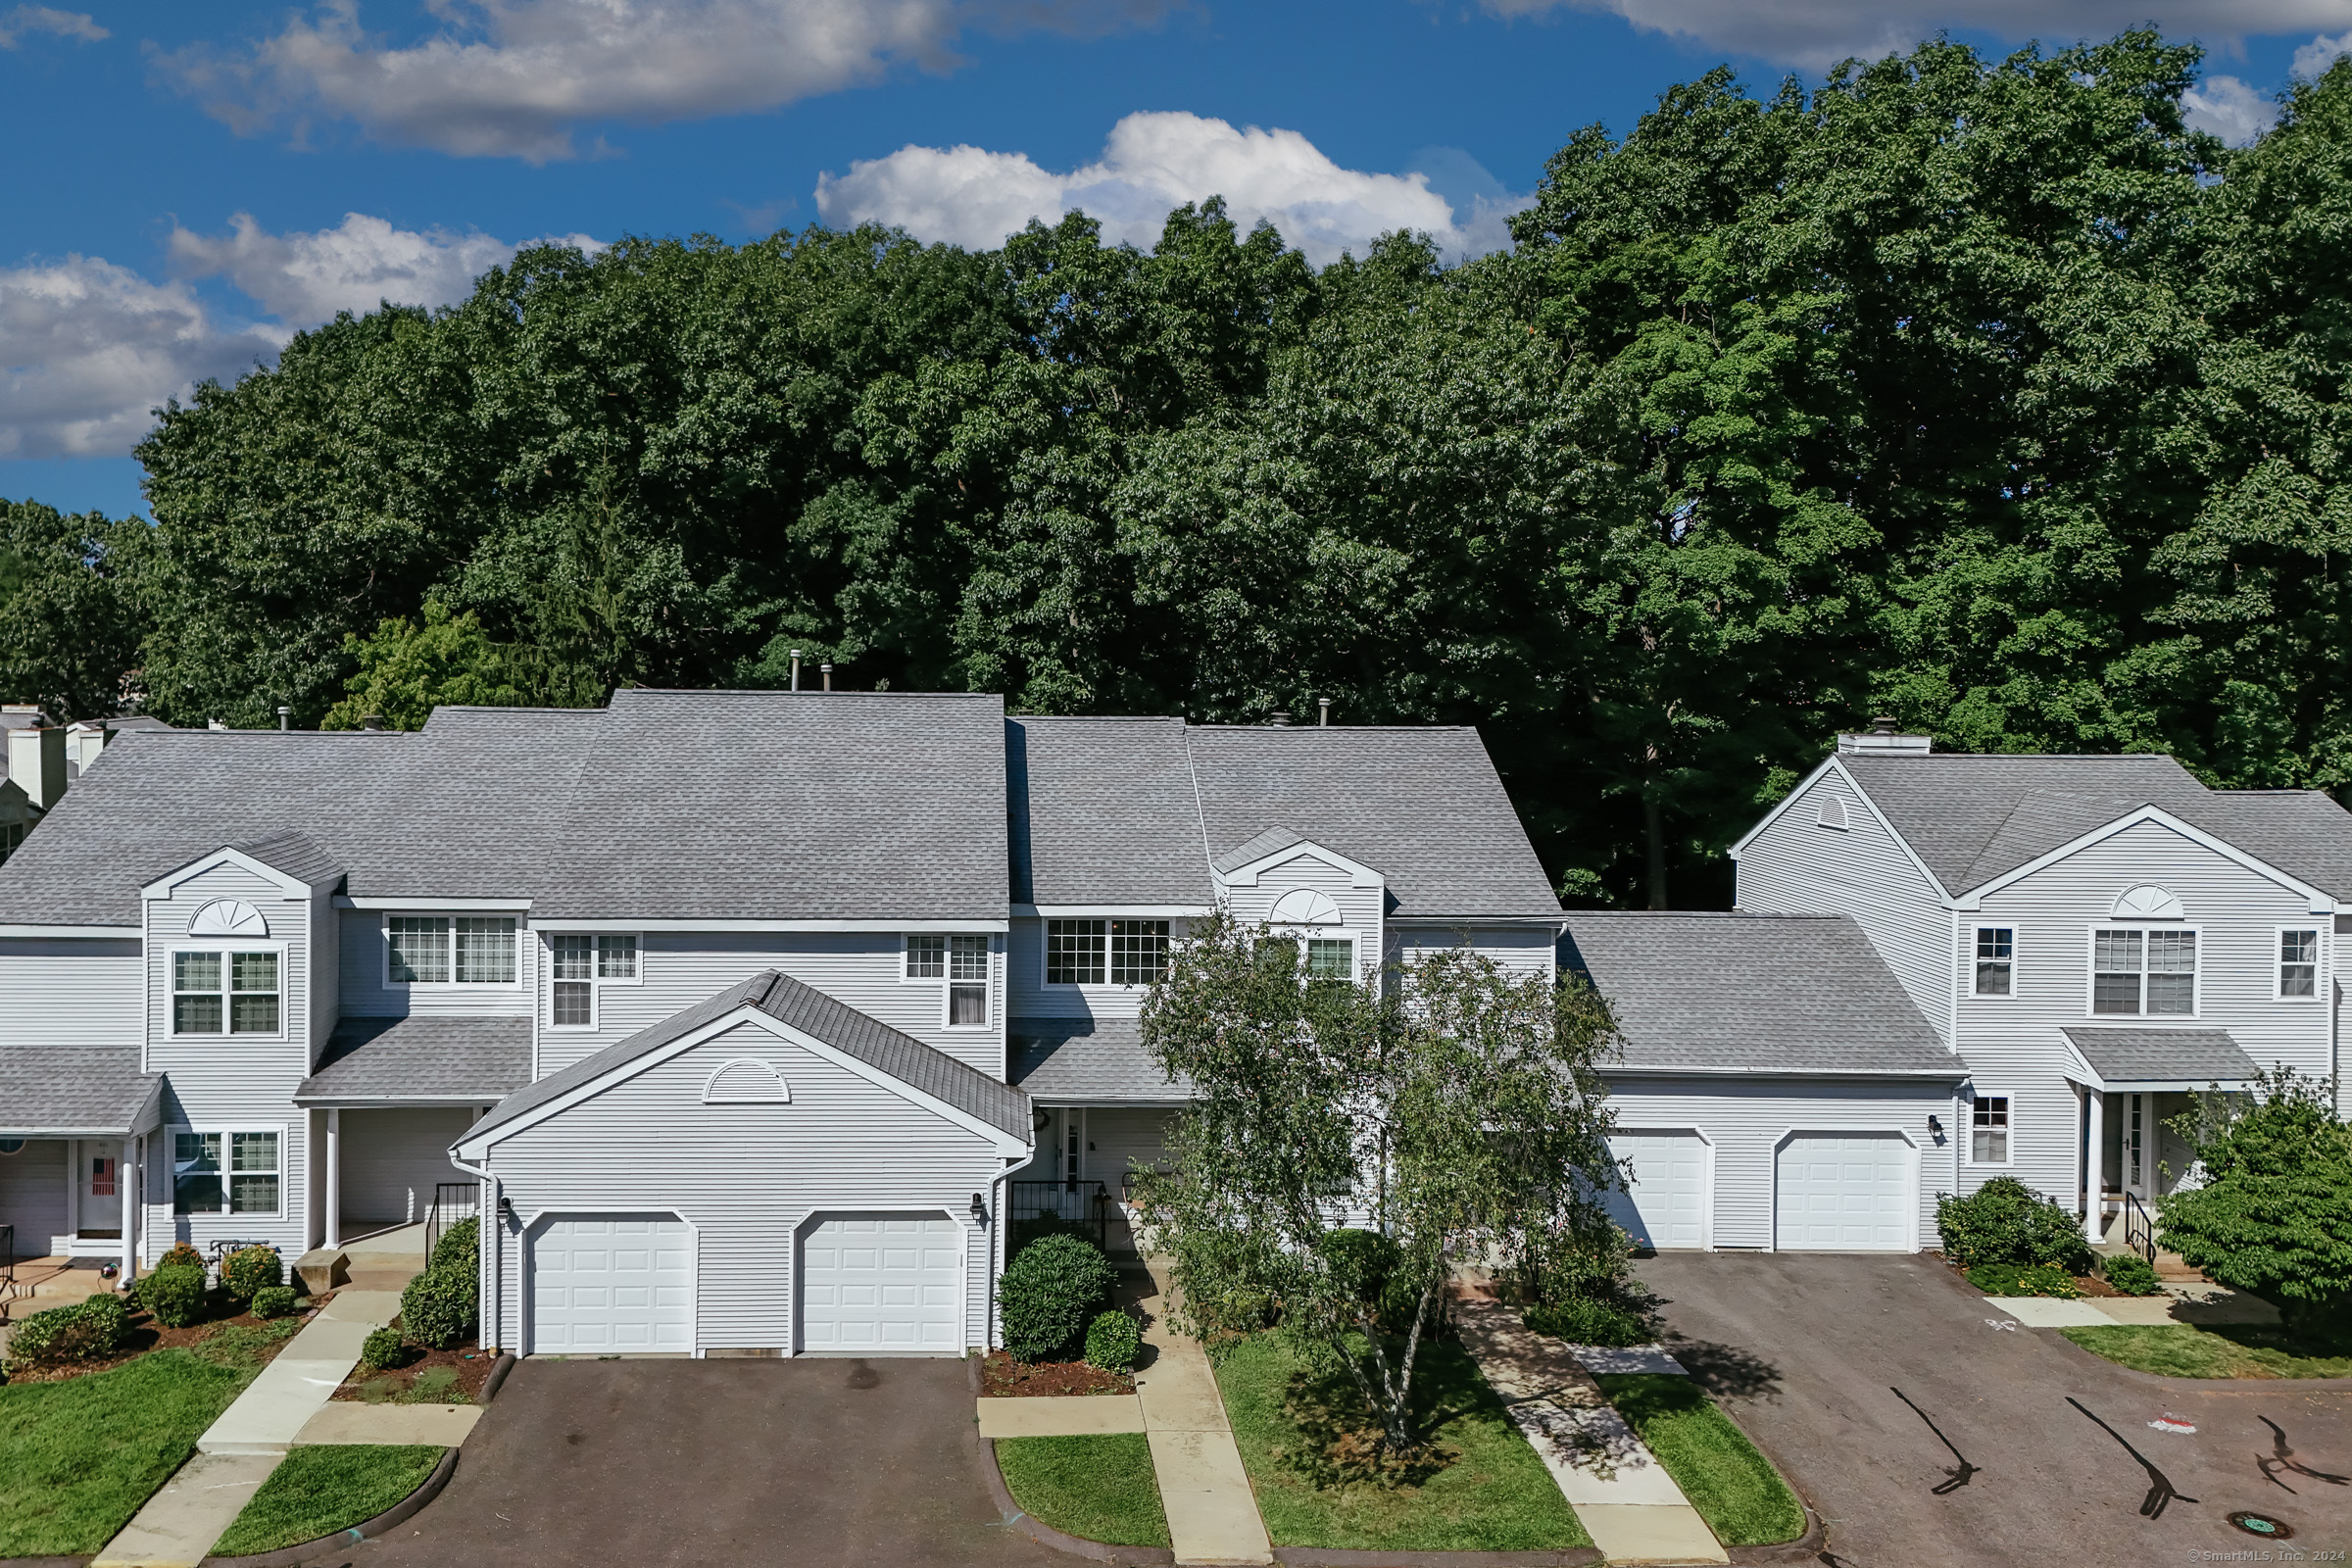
xmin=158 ymin=0 xmax=1169 ymax=163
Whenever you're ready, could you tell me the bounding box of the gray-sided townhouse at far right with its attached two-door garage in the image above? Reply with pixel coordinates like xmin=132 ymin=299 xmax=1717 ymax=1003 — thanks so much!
xmin=1571 ymin=726 xmax=2352 ymax=1249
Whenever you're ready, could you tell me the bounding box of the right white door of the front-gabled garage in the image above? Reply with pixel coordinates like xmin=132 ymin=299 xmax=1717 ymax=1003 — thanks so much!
xmin=800 ymin=1213 xmax=964 ymax=1356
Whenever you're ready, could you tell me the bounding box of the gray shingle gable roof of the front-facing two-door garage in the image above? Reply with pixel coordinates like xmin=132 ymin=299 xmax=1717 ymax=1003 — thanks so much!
xmin=466 ymin=968 xmax=1030 ymax=1143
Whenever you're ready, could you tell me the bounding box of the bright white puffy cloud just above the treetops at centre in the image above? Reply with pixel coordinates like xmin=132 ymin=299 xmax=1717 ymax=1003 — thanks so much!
xmin=816 ymin=113 xmax=1529 ymax=266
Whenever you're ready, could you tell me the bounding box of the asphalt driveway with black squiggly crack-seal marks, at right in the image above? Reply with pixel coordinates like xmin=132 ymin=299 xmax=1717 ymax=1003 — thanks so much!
xmin=1635 ymin=1253 xmax=2352 ymax=1568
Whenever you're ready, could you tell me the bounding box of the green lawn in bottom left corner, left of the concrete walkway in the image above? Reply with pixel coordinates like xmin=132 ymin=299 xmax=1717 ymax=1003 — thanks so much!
xmin=0 ymin=1349 xmax=252 ymax=1558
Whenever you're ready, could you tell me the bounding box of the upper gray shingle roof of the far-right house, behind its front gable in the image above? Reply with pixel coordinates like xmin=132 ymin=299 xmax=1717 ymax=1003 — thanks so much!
xmin=1839 ymin=753 xmax=2352 ymax=898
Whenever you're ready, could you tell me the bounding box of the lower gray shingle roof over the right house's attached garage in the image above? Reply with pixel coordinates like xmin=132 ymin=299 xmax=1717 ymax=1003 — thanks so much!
xmin=1562 ymin=912 xmax=1966 ymax=1079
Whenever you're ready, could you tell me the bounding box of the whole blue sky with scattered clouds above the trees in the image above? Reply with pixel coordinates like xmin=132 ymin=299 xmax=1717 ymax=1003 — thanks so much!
xmin=0 ymin=0 xmax=2352 ymax=514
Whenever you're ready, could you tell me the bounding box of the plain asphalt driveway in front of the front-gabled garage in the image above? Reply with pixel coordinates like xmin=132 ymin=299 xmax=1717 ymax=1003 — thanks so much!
xmin=357 ymin=1359 xmax=1072 ymax=1568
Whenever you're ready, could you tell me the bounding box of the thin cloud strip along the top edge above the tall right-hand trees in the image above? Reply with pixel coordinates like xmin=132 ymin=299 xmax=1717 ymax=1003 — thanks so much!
xmin=1482 ymin=0 xmax=2352 ymax=71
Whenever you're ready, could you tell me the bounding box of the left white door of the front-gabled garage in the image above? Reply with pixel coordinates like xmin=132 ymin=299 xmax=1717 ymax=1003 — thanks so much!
xmin=531 ymin=1213 xmax=694 ymax=1356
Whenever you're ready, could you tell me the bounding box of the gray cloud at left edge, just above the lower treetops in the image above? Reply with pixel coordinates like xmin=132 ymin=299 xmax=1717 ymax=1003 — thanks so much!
xmin=0 ymin=256 xmax=287 ymax=459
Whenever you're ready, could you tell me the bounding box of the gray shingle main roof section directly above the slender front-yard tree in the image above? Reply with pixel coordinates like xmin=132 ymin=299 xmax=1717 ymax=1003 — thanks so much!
xmin=1190 ymin=724 xmax=1559 ymax=919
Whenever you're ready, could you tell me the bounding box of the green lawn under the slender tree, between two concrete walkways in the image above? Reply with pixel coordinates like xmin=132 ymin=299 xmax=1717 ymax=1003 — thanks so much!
xmin=1216 ymin=1333 xmax=1592 ymax=1551
